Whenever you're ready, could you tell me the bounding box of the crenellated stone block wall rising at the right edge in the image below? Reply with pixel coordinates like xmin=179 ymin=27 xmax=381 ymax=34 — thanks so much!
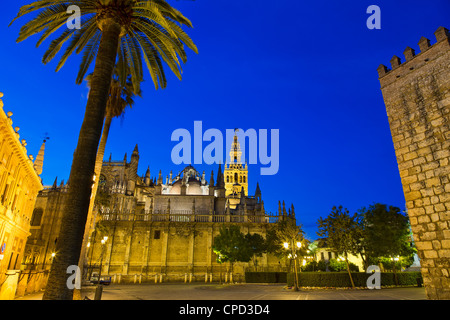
xmin=378 ymin=27 xmax=450 ymax=299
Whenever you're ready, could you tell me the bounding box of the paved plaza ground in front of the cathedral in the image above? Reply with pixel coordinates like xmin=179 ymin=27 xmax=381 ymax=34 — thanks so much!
xmin=16 ymin=283 xmax=426 ymax=301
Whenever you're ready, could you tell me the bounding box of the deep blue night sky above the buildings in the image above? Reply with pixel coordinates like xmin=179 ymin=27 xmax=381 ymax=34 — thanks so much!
xmin=0 ymin=0 xmax=450 ymax=239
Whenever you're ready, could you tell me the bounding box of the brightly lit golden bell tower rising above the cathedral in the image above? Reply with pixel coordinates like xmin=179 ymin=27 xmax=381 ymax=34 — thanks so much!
xmin=223 ymin=129 xmax=248 ymax=197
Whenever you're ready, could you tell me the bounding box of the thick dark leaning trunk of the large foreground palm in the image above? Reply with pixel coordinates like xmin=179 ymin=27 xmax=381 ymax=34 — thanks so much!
xmin=43 ymin=18 xmax=121 ymax=300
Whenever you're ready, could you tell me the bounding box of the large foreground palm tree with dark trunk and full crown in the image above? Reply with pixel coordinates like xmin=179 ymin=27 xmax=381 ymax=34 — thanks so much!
xmin=11 ymin=0 xmax=197 ymax=300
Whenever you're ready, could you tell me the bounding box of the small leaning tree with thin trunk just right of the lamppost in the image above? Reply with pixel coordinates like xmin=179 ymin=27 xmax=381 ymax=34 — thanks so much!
xmin=317 ymin=206 xmax=362 ymax=287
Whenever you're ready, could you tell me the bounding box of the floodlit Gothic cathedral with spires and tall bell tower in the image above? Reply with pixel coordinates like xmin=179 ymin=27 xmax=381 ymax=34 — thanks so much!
xmin=20 ymin=135 xmax=281 ymax=290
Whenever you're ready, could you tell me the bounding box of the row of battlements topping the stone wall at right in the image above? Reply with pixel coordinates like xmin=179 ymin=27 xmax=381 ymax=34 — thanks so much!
xmin=377 ymin=27 xmax=450 ymax=81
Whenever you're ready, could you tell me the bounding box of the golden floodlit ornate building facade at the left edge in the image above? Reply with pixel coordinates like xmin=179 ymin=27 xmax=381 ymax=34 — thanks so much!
xmin=0 ymin=93 xmax=45 ymax=300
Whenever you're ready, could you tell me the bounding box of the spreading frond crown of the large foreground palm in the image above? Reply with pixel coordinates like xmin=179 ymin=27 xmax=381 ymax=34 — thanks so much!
xmin=11 ymin=0 xmax=198 ymax=91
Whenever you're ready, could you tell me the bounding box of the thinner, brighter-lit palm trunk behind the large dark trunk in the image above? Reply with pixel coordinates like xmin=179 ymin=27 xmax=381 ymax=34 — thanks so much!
xmin=74 ymin=112 xmax=112 ymax=300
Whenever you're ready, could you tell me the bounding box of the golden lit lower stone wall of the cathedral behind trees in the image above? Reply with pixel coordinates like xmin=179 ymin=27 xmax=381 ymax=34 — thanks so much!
xmin=88 ymin=221 xmax=284 ymax=283
